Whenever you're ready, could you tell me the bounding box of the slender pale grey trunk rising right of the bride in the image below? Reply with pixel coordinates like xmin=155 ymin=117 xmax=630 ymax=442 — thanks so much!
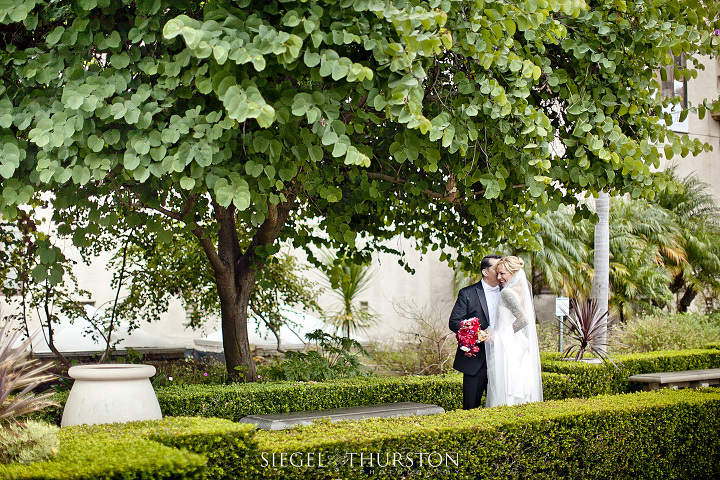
xmin=592 ymin=192 xmax=610 ymax=351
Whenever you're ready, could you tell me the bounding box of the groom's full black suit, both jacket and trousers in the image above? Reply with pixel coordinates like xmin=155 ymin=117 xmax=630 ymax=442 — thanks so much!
xmin=449 ymin=282 xmax=490 ymax=410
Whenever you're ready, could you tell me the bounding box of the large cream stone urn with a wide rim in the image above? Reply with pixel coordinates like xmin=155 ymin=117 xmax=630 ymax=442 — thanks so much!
xmin=60 ymin=363 xmax=162 ymax=427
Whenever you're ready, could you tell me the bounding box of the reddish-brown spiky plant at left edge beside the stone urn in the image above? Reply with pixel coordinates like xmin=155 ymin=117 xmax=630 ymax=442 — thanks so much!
xmin=0 ymin=317 xmax=57 ymax=425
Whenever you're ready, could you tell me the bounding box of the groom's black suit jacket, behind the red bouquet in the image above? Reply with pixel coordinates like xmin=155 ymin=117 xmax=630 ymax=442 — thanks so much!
xmin=449 ymin=282 xmax=490 ymax=375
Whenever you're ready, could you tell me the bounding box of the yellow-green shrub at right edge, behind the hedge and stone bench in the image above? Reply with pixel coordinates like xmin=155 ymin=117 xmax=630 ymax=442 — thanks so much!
xmin=621 ymin=313 xmax=720 ymax=353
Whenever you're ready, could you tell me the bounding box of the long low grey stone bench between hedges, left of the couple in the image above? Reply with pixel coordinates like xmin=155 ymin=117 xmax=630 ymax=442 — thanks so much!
xmin=240 ymin=402 xmax=445 ymax=430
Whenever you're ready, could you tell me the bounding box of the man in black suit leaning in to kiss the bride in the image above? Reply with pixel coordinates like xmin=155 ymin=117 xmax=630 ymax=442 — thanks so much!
xmin=450 ymin=255 xmax=501 ymax=410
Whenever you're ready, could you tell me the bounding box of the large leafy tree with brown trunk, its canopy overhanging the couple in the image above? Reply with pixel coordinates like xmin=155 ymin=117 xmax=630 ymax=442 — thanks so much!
xmin=0 ymin=0 xmax=717 ymax=379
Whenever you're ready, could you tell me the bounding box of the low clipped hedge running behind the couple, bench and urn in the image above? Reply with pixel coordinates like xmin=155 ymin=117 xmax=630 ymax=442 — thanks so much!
xmin=32 ymin=349 xmax=720 ymax=424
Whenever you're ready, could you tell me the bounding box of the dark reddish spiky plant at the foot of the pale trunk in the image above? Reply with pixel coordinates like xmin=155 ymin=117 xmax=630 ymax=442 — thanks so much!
xmin=560 ymin=298 xmax=615 ymax=365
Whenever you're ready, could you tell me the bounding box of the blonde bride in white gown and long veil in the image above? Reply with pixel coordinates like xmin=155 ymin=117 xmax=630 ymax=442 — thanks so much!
xmin=485 ymin=256 xmax=543 ymax=407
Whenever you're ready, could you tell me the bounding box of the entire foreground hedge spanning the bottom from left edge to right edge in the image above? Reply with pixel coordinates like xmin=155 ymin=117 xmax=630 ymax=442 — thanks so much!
xmin=5 ymin=388 xmax=720 ymax=480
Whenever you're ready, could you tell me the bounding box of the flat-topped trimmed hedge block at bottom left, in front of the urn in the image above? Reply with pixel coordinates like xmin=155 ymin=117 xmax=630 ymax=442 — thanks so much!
xmin=0 ymin=418 xmax=257 ymax=480
